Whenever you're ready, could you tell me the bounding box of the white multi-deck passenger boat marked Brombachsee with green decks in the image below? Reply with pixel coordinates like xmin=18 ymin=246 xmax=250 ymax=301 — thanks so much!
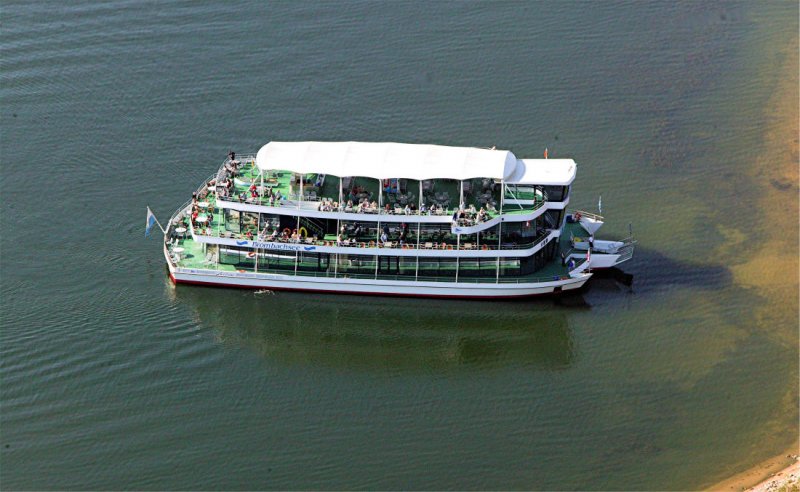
xmin=155 ymin=142 xmax=635 ymax=298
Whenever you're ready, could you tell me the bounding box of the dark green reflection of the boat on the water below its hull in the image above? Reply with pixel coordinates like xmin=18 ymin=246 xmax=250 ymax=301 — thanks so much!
xmin=169 ymin=286 xmax=585 ymax=372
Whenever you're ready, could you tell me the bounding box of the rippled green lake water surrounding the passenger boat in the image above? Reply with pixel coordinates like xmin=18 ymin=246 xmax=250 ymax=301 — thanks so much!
xmin=0 ymin=1 xmax=798 ymax=489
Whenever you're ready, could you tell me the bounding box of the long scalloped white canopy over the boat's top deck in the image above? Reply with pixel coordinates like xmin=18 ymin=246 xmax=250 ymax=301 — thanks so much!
xmin=256 ymin=142 xmax=520 ymax=180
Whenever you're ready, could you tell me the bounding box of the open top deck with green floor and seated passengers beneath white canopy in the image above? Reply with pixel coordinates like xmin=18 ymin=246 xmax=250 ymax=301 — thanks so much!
xmin=206 ymin=155 xmax=568 ymax=228
